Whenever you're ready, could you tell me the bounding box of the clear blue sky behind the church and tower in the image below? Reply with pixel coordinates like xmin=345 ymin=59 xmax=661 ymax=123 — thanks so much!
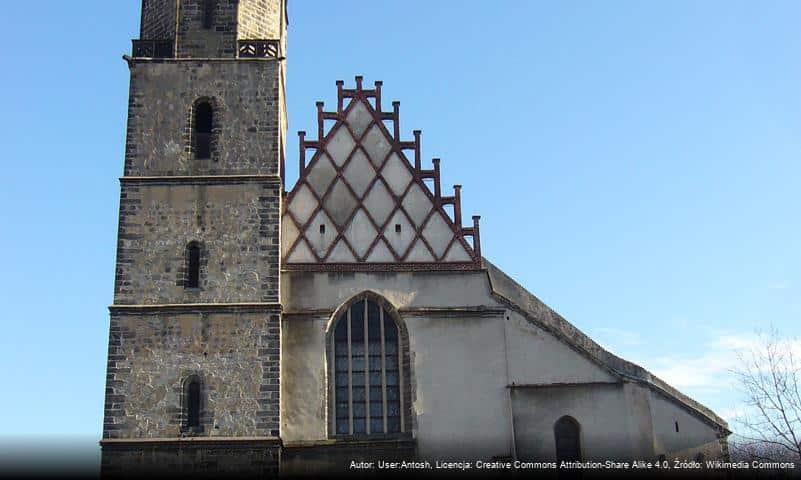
xmin=0 ymin=0 xmax=801 ymax=450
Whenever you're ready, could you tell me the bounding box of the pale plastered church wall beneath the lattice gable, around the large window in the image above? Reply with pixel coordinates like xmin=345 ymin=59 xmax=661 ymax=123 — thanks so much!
xmin=281 ymin=272 xmax=716 ymax=459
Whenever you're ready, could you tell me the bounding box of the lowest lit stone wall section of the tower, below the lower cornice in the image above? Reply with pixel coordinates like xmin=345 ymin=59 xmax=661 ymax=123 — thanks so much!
xmin=103 ymin=306 xmax=280 ymax=439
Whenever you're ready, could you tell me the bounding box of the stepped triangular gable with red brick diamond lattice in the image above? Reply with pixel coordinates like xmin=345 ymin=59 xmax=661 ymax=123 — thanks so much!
xmin=281 ymin=77 xmax=481 ymax=271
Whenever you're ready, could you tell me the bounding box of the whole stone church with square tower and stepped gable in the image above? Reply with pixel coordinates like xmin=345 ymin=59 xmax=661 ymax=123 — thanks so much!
xmin=100 ymin=0 xmax=730 ymax=474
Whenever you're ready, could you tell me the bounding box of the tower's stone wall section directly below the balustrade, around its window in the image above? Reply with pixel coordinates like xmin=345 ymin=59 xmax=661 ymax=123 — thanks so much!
xmin=125 ymin=60 xmax=281 ymax=176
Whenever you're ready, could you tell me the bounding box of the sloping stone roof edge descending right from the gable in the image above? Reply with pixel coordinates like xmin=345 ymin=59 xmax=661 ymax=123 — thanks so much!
xmin=482 ymin=257 xmax=731 ymax=435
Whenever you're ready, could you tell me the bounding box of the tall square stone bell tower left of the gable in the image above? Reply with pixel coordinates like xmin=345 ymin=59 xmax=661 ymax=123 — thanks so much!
xmin=101 ymin=0 xmax=287 ymax=474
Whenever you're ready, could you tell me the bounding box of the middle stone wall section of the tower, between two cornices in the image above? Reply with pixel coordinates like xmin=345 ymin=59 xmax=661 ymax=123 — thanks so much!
xmin=114 ymin=179 xmax=281 ymax=305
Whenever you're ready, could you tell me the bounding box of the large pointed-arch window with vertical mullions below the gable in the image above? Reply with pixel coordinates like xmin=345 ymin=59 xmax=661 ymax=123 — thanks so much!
xmin=332 ymin=295 xmax=408 ymax=436
